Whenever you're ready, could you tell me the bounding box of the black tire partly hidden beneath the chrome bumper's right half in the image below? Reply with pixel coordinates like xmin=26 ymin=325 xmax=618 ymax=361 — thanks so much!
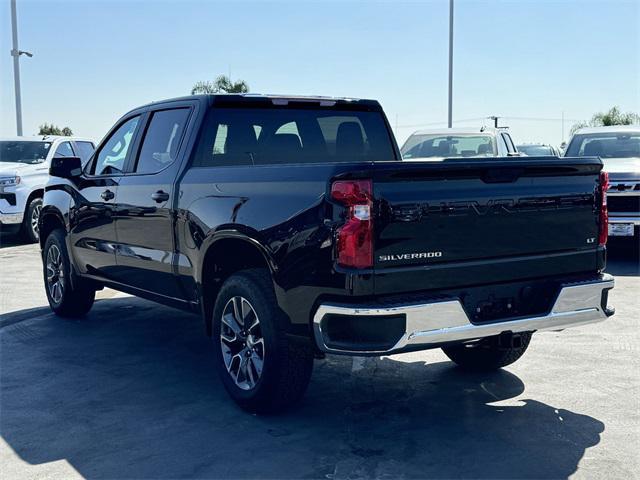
xmin=442 ymin=332 xmax=532 ymax=372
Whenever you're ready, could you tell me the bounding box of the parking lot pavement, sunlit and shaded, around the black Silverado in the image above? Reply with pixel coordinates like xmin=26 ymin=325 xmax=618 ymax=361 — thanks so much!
xmin=0 ymin=241 xmax=640 ymax=479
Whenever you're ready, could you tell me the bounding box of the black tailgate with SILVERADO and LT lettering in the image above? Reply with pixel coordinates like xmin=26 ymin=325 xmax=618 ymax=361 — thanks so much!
xmin=373 ymin=157 xmax=603 ymax=293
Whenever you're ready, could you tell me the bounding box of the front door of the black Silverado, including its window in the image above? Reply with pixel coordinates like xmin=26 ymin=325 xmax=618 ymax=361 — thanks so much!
xmin=69 ymin=116 xmax=140 ymax=279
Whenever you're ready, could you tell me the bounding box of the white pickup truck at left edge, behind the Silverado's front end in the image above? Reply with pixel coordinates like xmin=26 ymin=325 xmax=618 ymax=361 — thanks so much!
xmin=0 ymin=136 xmax=95 ymax=242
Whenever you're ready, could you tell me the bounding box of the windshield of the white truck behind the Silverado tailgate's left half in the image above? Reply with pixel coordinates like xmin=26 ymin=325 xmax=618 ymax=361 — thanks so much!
xmin=402 ymin=135 xmax=496 ymax=159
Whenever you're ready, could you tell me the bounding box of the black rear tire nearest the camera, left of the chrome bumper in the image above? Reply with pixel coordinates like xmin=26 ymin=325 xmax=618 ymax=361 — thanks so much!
xmin=212 ymin=269 xmax=313 ymax=413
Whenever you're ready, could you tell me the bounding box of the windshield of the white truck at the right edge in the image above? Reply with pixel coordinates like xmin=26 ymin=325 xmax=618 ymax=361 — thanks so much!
xmin=565 ymin=132 xmax=640 ymax=158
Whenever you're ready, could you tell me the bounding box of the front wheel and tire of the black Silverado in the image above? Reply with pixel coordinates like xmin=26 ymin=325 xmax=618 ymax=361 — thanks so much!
xmin=42 ymin=229 xmax=96 ymax=318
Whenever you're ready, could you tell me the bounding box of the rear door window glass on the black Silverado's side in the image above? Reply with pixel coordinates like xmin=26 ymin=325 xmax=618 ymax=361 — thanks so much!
xmin=136 ymin=108 xmax=189 ymax=173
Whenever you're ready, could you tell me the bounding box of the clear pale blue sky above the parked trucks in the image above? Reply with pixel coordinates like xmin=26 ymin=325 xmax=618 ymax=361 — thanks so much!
xmin=0 ymin=0 xmax=640 ymax=144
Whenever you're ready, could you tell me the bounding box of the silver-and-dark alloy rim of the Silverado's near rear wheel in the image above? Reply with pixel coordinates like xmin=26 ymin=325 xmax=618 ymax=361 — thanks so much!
xmin=220 ymin=296 xmax=265 ymax=390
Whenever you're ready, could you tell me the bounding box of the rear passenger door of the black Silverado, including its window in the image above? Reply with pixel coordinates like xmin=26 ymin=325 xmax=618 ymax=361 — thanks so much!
xmin=116 ymin=105 xmax=193 ymax=298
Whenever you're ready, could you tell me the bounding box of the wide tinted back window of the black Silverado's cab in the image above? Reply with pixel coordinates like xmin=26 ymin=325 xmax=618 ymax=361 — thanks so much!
xmin=193 ymin=108 xmax=396 ymax=167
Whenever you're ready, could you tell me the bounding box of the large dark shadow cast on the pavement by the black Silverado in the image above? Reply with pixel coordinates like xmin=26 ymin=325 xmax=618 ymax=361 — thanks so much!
xmin=0 ymin=298 xmax=604 ymax=479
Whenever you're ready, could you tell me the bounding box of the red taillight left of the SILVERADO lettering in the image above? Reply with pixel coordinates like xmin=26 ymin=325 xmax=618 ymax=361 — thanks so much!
xmin=331 ymin=180 xmax=373 ymax=268
